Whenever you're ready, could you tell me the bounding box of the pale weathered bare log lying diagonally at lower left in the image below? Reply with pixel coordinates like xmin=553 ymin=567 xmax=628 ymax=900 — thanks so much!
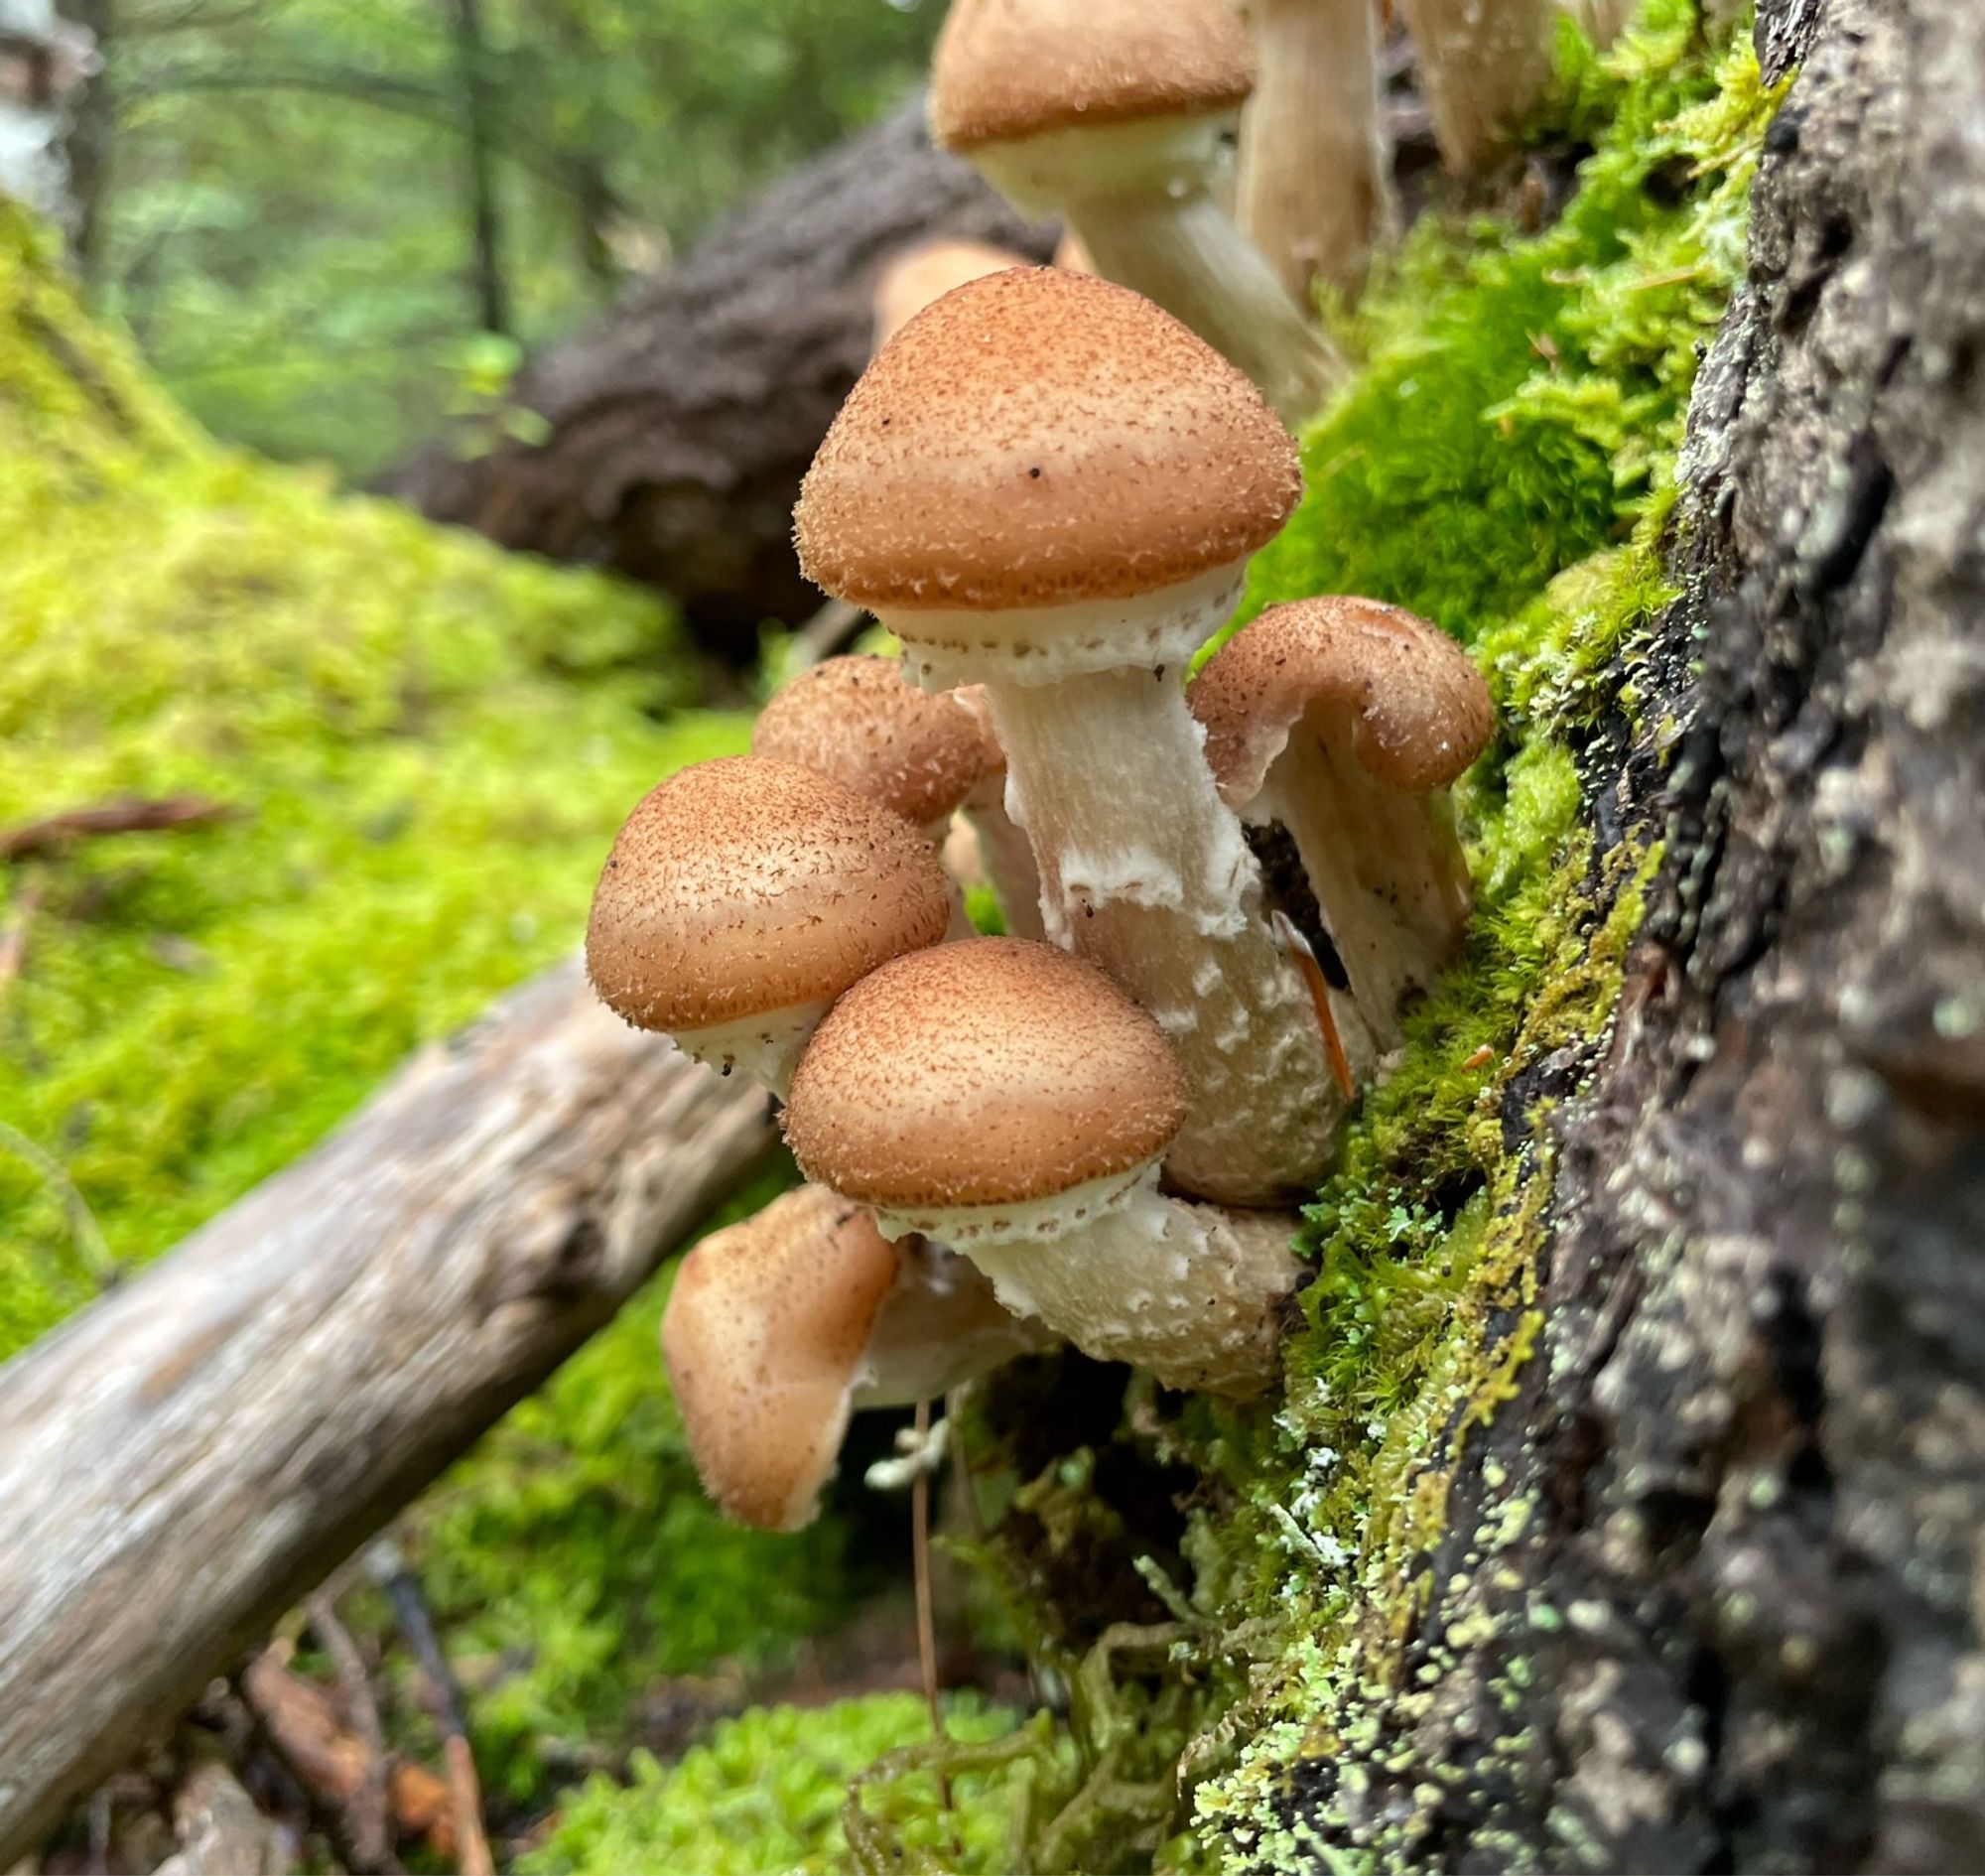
xmin=0 ymin=965 xmax=772 ymax=1868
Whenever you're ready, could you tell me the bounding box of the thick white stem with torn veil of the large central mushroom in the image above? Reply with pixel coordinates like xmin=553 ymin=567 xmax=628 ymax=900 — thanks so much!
xmin=901 ymin=568 xmax=1344 ymax=1205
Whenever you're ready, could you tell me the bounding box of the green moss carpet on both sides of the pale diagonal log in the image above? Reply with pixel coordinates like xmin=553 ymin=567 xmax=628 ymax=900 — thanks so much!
xmin=0 ymin=204 xmax=848 ymax=1799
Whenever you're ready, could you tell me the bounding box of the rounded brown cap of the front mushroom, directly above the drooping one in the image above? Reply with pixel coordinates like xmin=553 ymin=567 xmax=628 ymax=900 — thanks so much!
xmin=786 ymin=939 xmax=1185 ymax=1209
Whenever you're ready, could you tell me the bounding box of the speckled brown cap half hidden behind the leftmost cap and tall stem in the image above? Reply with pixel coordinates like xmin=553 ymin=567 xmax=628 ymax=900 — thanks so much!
xmin=750 ymin=657 xmax=987 ymax=828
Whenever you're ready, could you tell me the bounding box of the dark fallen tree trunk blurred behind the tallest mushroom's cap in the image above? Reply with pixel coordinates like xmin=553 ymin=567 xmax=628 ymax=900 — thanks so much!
xmin=389 ymin=103 xmax=1052 ymax=659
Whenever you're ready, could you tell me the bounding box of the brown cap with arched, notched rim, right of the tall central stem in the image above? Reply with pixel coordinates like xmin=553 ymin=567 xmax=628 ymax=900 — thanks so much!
xmin=1187 ymin=598 xmax=1495 ymax=808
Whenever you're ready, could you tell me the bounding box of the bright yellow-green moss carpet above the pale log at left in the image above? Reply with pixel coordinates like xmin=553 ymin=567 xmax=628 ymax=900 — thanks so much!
xmin=0 ymin=198 xmax=742 ymax=1354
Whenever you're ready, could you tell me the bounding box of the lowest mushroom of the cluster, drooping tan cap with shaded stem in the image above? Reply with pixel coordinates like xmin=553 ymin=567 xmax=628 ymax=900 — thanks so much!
xmin=661 ymin=1185 xmax=1044 ymax=1531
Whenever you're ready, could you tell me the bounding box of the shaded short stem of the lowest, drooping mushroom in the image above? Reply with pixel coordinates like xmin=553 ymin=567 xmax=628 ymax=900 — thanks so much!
xmin=854 ymin=1237 xmax=1052 ymax=1411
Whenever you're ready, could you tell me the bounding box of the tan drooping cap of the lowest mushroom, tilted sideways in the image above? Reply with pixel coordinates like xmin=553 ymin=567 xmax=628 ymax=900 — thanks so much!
xmin=661 ymin=1185 xmax=897 ymax=1531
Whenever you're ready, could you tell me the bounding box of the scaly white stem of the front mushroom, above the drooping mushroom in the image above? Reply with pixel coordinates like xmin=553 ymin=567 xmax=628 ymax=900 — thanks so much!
xmin=877 ymin=1165 xmax=1302 ymax=1396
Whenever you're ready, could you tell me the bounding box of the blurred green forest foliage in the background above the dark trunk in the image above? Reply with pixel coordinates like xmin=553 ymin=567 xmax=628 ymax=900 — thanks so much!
xmin=93 ymin=0 xmax=943 ymax=474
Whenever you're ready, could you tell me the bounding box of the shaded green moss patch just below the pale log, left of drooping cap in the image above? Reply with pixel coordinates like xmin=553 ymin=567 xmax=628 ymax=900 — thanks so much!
xmin=415 ymin=1181 xmax=858 ymax=1807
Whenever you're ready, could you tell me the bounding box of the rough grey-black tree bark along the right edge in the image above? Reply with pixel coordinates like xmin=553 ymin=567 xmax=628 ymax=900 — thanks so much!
xmin=1284 ymin=0 xmax=1985 ymax=1872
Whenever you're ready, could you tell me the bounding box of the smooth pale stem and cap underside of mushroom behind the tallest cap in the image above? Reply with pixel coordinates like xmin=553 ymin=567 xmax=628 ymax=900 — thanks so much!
xmin=969 ymin=115 xmax=1344 ymax=421
